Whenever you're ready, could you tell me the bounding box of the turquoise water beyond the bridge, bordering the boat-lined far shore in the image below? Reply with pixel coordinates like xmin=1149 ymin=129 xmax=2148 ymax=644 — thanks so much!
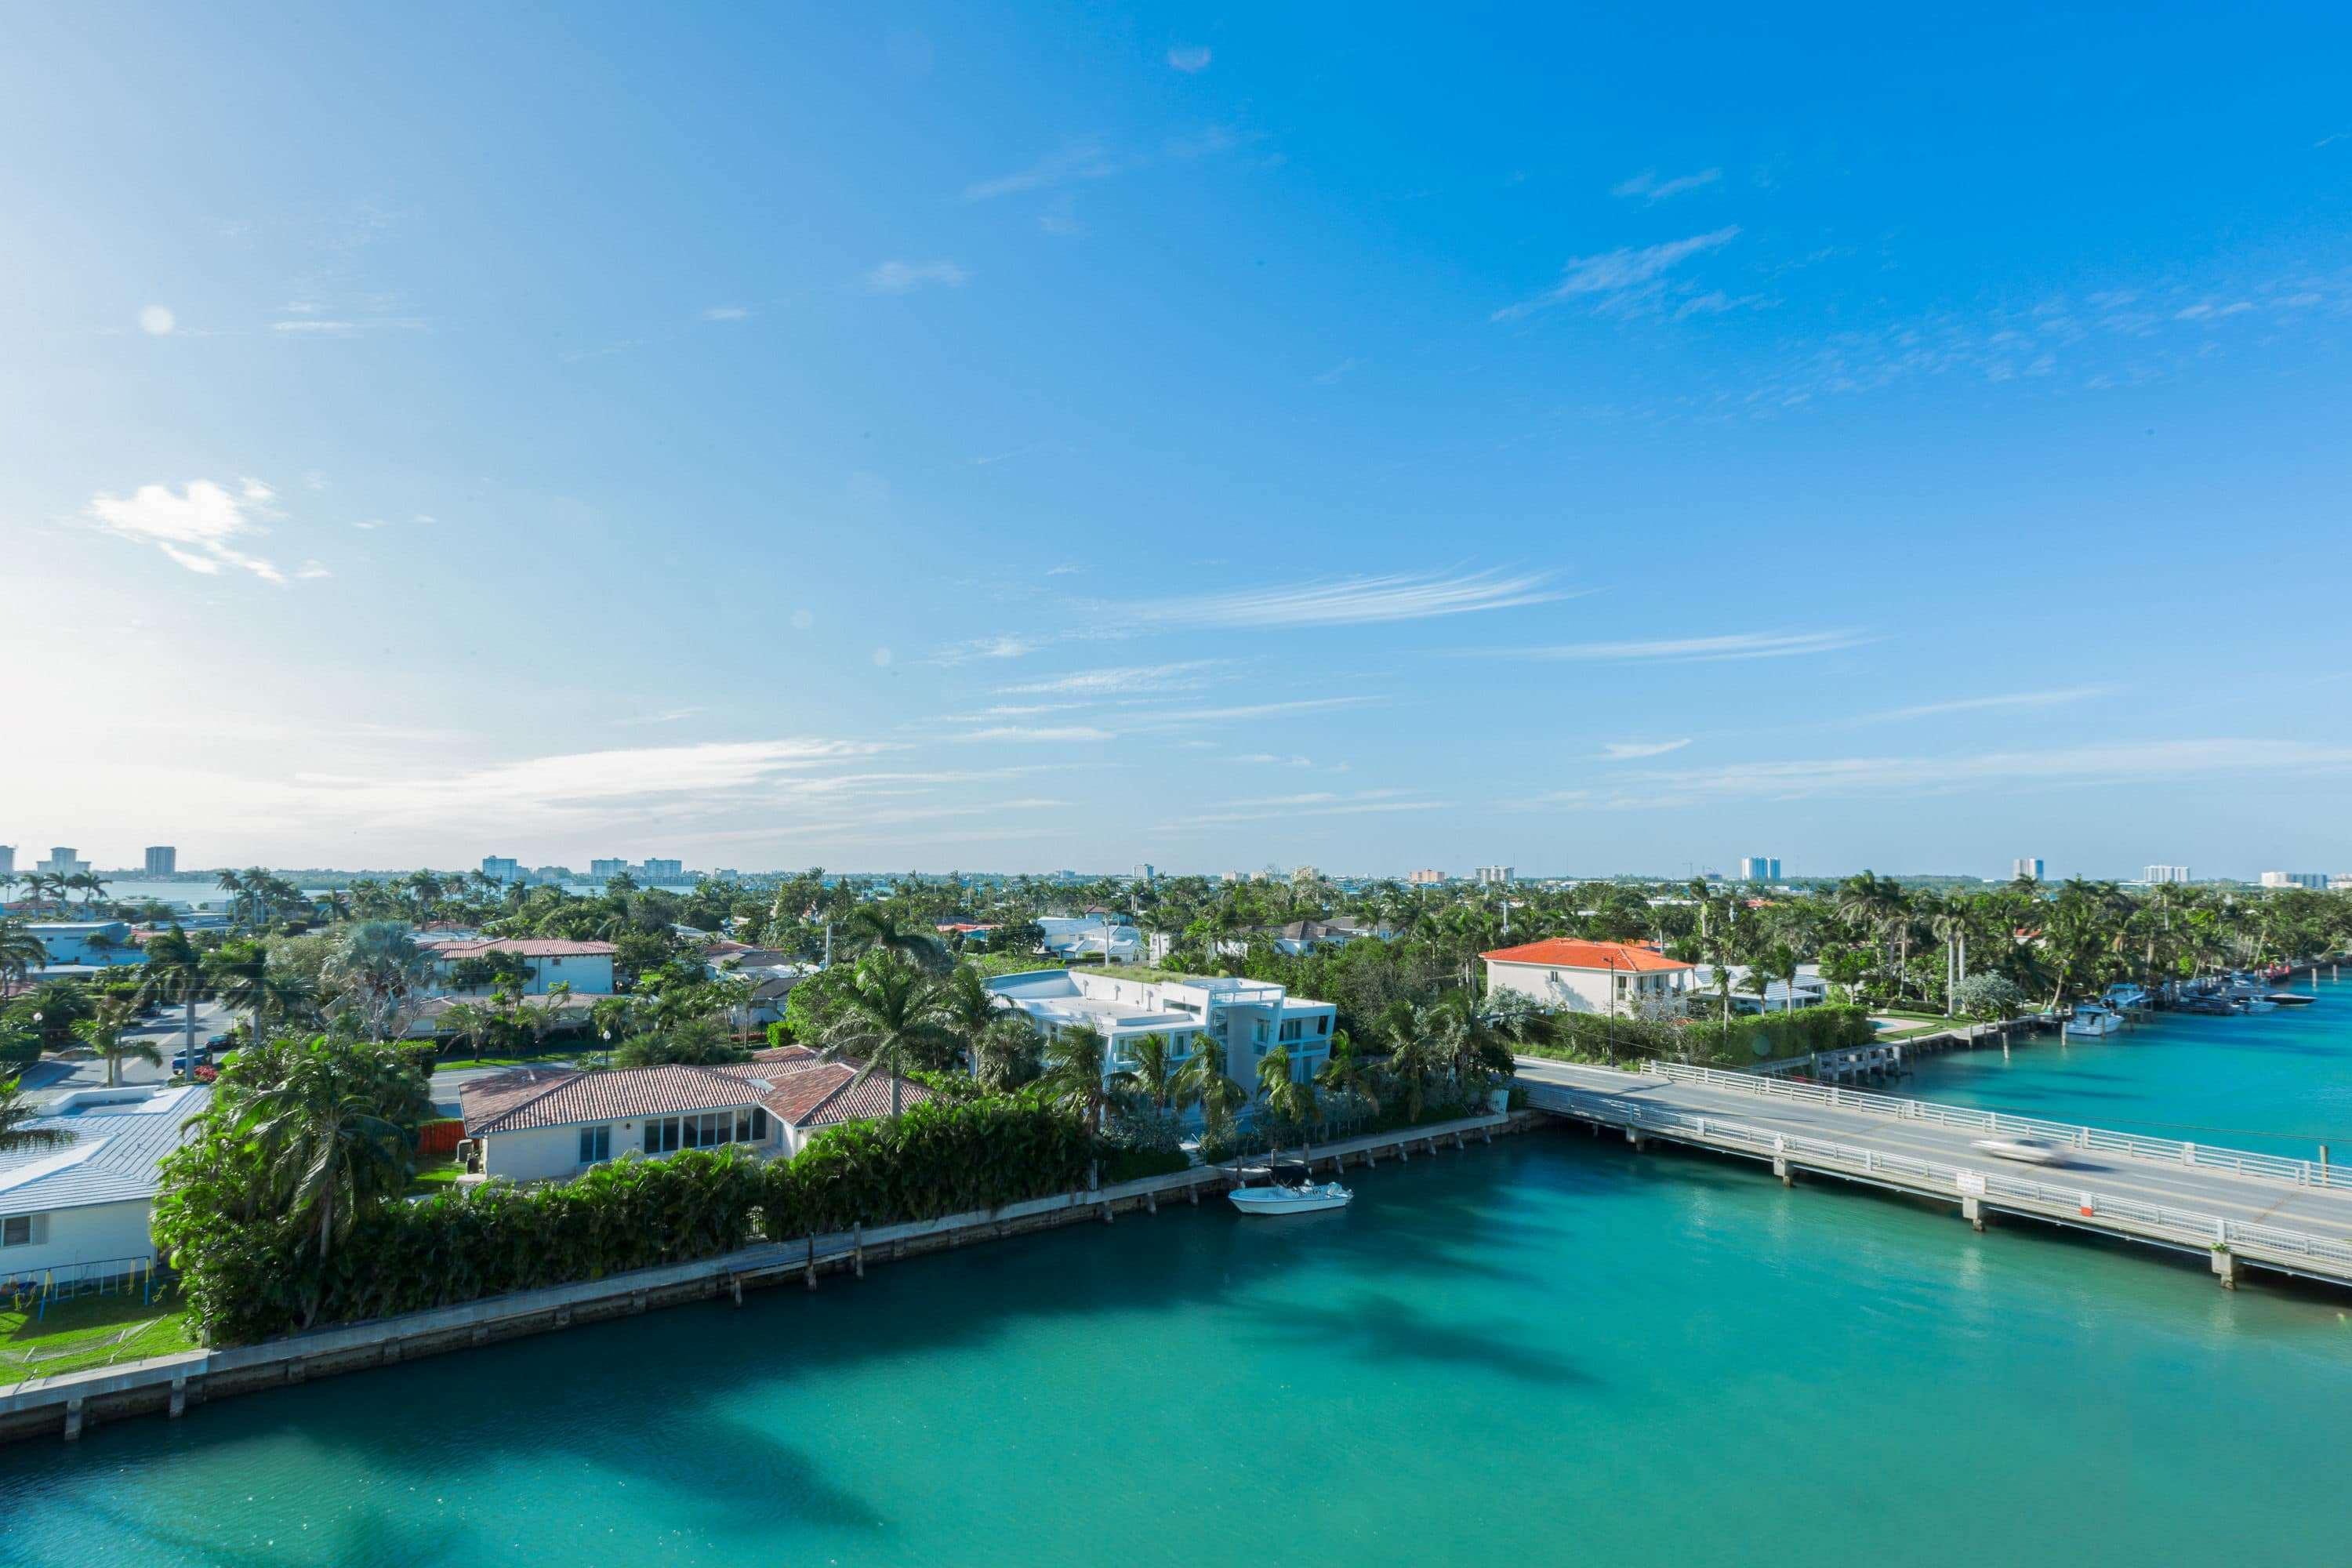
xmin=1896 ymin=975 xmax=2352 ymax=1161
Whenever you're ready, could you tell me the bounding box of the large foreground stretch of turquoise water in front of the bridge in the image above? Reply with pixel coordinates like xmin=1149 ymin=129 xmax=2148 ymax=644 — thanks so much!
xmin=0 ymin=1001 xmax=2352 ymax=1568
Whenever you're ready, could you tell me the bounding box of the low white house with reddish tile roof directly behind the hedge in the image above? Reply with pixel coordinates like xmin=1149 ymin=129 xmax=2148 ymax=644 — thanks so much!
xmin=459 ymin=1046 xmax=931 ymax=1182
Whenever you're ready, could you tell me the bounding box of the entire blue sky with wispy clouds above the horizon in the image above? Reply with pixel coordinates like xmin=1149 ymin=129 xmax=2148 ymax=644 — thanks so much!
xmin=0 ymin=5 xmax=2352 ymax=874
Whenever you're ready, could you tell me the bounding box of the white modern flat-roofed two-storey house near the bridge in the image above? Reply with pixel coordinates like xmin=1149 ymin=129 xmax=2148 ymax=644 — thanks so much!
xmin=988 ymin=968 xmax=1338 ymax=1088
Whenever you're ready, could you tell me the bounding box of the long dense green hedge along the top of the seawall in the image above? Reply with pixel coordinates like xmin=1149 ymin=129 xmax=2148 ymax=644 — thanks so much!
xmin=174 ymin=1093 xmax=1089 ymax=1345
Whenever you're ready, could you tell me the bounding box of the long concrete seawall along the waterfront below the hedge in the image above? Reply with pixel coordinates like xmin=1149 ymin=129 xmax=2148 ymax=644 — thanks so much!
xmin=0 ymin=1112 xmax=1541 ymax=1443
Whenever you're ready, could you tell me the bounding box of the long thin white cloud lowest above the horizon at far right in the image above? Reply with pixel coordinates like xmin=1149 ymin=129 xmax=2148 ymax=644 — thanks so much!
xmin=1531 ymin=739 xmax=2352 ymax=808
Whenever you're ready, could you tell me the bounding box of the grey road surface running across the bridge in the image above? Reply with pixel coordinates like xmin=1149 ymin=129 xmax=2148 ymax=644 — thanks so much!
xmin=1519 ymin=1055 xmax=2352 ymax=1243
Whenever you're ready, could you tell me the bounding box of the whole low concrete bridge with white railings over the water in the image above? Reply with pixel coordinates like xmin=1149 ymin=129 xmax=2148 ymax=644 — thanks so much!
xmin=1517 ymin=1055 xmax=2352 ymax=1288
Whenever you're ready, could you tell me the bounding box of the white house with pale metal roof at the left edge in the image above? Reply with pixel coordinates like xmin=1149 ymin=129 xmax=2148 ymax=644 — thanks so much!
xmin=0 ymin=1083 xmax=212 ymax=1286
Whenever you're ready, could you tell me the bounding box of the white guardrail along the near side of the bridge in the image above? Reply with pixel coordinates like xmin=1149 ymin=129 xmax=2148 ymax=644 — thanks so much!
xmin=1529 ymin=1083 xmax=2352 ymax=1279
